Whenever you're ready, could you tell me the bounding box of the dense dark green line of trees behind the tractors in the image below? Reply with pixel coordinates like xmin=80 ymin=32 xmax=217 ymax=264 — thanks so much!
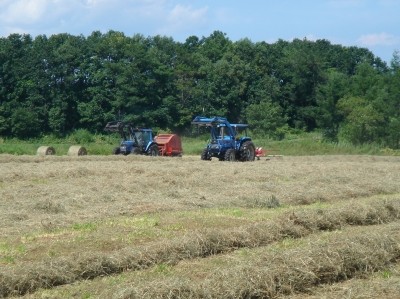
xmin=0 ymin=31 xmax=400 ymax=148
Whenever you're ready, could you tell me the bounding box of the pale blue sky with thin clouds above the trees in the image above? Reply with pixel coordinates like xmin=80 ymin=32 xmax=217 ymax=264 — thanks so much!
xmin=0 ymin=0 xmax=400 ymax=62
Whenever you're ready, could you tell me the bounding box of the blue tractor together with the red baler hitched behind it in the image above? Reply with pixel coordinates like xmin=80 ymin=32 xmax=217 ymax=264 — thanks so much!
xmin=104 ymin=121 xmax=182 ymax=156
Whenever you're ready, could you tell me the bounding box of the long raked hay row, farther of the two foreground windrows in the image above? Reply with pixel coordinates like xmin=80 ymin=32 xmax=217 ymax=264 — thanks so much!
xmin=0 ymin=199 xmax=400 ymax=297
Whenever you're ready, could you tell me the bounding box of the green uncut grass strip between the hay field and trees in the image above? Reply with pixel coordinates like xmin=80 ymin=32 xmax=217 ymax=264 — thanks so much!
xmin=0 ymin=130 xmax=400 ymax=156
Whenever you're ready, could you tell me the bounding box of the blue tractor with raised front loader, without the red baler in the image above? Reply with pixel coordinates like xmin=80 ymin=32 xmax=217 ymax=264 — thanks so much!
xmin=192 ymin=116 xmax=256 ymax=162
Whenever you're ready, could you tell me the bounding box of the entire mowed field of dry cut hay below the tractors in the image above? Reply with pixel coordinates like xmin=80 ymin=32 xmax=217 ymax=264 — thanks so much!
xmin=0 ymin=155 xmax=400 ymax=299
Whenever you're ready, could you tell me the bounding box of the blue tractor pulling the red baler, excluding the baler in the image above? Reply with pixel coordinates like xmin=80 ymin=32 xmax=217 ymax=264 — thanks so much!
xmin=104 ymin=121 xmax=159 ymax=156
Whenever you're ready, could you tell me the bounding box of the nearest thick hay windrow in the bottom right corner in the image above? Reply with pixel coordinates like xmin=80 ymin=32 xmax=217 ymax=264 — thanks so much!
xmin=116 ymin=223 xmax=400 ymax=299
